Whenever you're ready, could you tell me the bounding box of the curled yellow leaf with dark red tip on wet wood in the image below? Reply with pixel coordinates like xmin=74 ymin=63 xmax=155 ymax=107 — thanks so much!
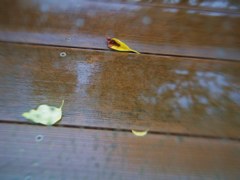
xmin=107 ymin=38 xmax=140 ymax=54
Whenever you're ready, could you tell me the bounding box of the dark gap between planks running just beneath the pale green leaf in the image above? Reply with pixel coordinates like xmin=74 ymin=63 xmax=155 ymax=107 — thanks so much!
xmin=0 ymin=120 xmax=240 ymax=142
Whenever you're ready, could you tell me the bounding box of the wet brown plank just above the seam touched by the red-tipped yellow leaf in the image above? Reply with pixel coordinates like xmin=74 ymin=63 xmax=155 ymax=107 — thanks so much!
xmin=0 ymin=0 xmax=240 ymax=60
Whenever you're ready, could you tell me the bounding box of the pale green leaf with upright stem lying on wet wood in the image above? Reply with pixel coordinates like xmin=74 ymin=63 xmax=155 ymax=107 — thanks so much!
xmin=22 ymin=100 xmax=64 ymax=126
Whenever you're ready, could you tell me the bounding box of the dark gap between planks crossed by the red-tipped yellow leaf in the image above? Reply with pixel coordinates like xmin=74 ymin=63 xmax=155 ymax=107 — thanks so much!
xmin=0 ymin=40 xmax=240 ymax=62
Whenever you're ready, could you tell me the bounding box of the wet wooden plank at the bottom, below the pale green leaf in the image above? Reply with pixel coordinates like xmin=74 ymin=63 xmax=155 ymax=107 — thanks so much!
xmin=0 ymin=123 xmax=240 ymax=180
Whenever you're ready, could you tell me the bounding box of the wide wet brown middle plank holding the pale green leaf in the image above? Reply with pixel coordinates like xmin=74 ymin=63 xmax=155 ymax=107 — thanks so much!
xmin=0 ymin=43 xmax=240 ymax=138
